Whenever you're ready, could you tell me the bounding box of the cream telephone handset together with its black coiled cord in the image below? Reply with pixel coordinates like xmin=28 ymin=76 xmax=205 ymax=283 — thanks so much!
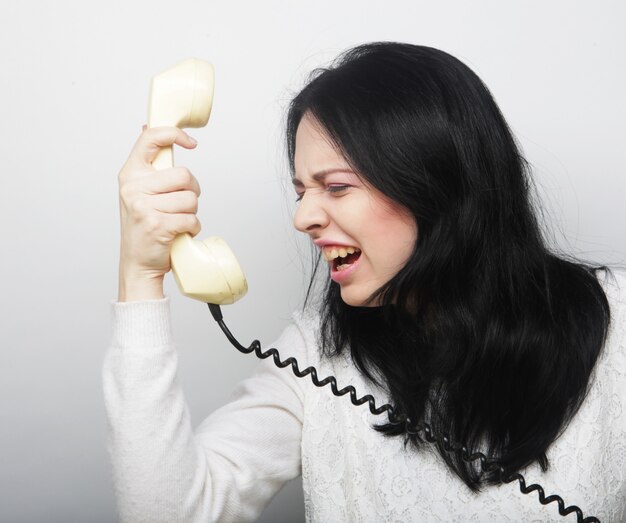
xmin=148 ymin=59 xmax=600 ymax=523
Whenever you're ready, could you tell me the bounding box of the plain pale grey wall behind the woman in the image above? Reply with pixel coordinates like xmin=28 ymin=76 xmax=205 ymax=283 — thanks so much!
xmin=0 ymin=0 xmax=626 ymax=523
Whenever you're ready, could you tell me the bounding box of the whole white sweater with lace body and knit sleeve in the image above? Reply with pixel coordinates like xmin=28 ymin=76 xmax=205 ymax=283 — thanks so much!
xmin=103 ymin=273 xmax=626 ymax=523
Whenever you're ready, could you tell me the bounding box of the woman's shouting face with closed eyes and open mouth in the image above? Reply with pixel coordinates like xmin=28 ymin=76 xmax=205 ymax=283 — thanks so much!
xmin=293 ymin=114 xmax=417 ymax=306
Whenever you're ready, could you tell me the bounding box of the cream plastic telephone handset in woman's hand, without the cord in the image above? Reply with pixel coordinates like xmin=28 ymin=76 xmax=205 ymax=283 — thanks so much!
xmin=148 ymin=58 xmax=248 ymax=305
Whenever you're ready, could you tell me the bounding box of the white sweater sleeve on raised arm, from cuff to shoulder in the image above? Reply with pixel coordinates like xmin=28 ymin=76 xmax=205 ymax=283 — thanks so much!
xmin=103 ymin=298 xmax=304 ymax=523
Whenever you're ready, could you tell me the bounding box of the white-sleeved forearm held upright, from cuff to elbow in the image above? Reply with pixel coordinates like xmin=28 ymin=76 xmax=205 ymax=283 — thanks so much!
xmin=103 ymin=300 xmax=201 ymax=522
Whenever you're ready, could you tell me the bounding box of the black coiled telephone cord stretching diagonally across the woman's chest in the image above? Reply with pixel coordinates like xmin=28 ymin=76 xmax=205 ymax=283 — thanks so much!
xmin=207 ymin=303 xmax=600 ymax=523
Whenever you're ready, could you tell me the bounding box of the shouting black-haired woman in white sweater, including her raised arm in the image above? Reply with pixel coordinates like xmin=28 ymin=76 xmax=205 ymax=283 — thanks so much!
xmin=104 ymin=43 xmax=626 ymax=521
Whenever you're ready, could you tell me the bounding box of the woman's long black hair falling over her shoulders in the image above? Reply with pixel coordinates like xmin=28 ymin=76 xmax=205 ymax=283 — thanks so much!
xmin=286 ymin=42 xmax=610 ymax=490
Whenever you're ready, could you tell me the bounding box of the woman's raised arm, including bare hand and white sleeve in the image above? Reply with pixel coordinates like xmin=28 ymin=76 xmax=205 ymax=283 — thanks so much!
xmin=108 ymin=127 xmax=302 ymax=522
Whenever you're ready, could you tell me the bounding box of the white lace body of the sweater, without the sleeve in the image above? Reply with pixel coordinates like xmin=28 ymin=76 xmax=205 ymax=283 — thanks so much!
xmin=300 ymin=273 xmax=626 ymax=523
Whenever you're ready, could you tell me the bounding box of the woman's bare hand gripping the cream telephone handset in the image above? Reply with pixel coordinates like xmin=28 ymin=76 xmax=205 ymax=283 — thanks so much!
xmin=118 ymin=126 xmax=200 ymax=301
